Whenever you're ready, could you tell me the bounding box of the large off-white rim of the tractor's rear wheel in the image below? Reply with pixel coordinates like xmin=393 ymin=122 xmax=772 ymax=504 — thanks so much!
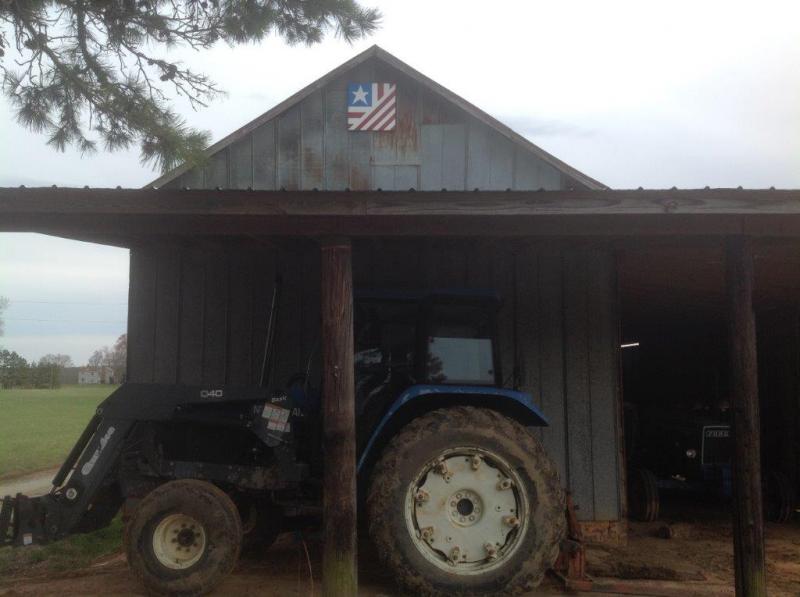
xmin=405 ymin=447 xmax=529 ymax=575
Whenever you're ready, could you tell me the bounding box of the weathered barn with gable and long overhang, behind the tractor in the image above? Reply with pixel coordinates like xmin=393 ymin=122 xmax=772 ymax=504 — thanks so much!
xmin=0 ymin=46 xmax=800 ymax=582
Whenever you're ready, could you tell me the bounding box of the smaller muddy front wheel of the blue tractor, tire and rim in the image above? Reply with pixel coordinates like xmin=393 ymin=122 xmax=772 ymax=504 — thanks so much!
xmin=124 ymin=479 xmax=242 ymax=595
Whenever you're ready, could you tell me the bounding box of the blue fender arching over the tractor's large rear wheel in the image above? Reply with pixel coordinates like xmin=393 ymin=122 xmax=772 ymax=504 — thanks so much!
xmin=358 ymin=385 xmax=549 ymax=473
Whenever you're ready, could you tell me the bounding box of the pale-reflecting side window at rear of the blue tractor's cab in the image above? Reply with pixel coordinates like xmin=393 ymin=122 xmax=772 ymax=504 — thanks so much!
xmin=427 ymin=304 xmax=496 ymax=385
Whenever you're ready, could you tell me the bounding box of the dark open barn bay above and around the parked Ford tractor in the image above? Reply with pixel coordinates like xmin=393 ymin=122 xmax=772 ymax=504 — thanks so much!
xmin=618 ymin=242 xmax=800 ymax=519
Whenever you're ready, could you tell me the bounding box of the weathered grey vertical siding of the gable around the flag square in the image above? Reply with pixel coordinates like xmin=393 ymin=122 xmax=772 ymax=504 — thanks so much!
xmin=166 ymin=61 xmax=575 ymax=190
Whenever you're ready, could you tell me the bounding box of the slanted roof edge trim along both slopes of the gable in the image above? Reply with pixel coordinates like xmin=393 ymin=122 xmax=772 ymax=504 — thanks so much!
xmin=145 ymin=45 xmax=609 ymax=189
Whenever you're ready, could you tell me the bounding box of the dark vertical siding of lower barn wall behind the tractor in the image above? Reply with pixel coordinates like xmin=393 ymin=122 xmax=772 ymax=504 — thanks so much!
xmin=128 ymin=238 xmax=621 ymax=520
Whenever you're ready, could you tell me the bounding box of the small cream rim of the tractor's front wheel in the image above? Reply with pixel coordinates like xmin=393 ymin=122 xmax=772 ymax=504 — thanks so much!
xmin=153 ymin=514 xmax=206 ymax=570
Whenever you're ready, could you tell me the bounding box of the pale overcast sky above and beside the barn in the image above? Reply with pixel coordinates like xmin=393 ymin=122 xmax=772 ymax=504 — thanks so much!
xmin=0 ymin=0 xmax=800 ymax=364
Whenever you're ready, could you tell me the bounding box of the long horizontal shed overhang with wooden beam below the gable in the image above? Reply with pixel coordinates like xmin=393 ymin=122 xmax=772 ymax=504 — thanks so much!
xmin=0 ymin=188 xmax=800 ymax=246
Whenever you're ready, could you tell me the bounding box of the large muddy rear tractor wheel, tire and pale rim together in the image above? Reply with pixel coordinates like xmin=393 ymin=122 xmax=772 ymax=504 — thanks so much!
xmin=367 ymin=406 xmax=566 ymax=595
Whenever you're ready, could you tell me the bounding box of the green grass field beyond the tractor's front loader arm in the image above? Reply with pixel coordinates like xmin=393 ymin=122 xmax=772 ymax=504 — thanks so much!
xmin=0 ymin=385 xmax=117 ymax=479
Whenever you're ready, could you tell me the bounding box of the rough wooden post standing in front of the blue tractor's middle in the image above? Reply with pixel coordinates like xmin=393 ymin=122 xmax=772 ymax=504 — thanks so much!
xmin=321 ymin=239 xmax=358 ymax=597
